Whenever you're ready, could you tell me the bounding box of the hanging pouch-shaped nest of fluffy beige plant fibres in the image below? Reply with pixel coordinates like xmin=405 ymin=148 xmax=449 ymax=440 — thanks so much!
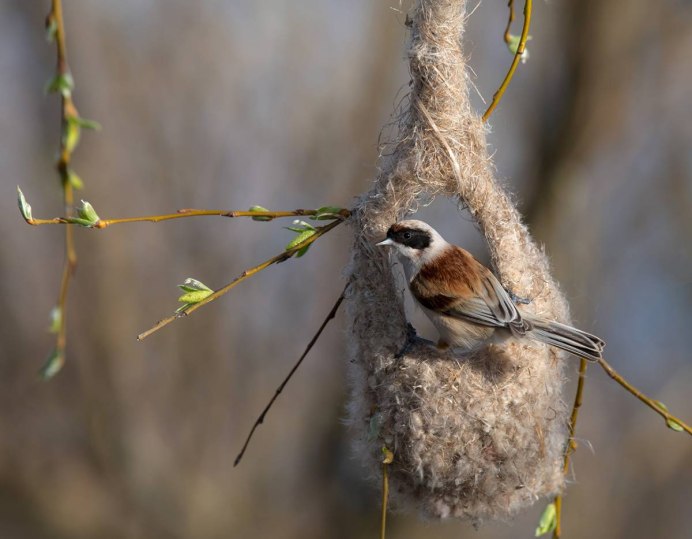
xmin=347 ymin=0 xmax=569 ymax=522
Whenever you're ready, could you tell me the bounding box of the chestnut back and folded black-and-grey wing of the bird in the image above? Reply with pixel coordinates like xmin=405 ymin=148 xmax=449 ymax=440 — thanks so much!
xmin=411 ymin=247 xmax=528 ymax=333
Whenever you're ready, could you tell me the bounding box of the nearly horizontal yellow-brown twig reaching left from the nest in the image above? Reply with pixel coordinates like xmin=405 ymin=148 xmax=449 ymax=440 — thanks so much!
xmin=27 ymin=208 xmax=350 ymax=225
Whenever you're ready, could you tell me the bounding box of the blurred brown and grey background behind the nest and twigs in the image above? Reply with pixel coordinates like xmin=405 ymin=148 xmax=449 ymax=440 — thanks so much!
xmin=0 ymin=0 xmax=692 ymax=539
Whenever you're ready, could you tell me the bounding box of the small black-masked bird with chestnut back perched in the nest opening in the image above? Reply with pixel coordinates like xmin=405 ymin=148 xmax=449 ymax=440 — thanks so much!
xmin=377 ymin=220 xmax=605 ymax=361
